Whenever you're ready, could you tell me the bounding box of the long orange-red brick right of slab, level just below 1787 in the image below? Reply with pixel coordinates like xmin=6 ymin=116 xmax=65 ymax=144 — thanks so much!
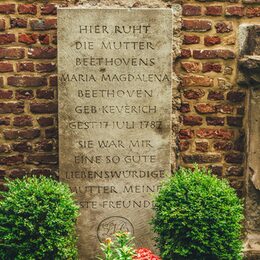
xmin=196 ymin=128 xmax=234 ymax=140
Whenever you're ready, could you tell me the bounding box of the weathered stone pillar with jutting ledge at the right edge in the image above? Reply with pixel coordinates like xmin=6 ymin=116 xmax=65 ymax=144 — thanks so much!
xmin=239 ymin=24 xmax=260 ymax=259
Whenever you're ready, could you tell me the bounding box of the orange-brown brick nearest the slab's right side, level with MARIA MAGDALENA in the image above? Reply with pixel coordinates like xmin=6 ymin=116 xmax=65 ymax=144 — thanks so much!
xmin=181 ymin=75 xmax=213 ymax=87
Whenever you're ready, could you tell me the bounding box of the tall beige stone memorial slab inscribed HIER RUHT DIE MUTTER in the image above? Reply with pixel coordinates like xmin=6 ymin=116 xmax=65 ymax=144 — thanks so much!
xmin=58 ymin=8 xmax=173 ymax=260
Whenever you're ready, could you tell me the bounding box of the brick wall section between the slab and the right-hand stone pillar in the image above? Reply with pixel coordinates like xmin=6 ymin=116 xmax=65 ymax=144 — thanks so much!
xmin=179 ymin=0 xmax=260 ymax=194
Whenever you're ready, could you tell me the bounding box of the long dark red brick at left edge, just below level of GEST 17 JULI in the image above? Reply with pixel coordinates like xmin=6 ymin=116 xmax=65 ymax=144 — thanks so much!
xmin=3 ymin=129 xmax=41 ymax=140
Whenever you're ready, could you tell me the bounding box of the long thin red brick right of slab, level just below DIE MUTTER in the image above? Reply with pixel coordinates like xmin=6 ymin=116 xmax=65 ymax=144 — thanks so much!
xmin=193 ymin=50 xmax=235 ymax=60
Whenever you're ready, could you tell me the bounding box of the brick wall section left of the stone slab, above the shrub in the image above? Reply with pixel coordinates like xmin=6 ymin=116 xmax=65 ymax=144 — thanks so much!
xmin=0 ymin=1 xmax=58 ymax=189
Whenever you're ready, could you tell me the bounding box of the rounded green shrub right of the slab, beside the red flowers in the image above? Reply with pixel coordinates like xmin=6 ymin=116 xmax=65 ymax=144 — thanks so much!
xmin=152 ymin=166 xmax=243 ymax=260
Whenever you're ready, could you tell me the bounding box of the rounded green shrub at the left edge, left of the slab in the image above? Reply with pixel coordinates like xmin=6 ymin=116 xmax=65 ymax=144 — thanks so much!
xmin=0 ymin=177 xmax=78 ymax=260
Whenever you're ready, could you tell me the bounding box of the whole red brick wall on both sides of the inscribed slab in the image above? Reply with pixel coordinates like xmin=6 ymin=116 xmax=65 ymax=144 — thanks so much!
xmin=0 ymin=0 xmax=260 ymax=193
